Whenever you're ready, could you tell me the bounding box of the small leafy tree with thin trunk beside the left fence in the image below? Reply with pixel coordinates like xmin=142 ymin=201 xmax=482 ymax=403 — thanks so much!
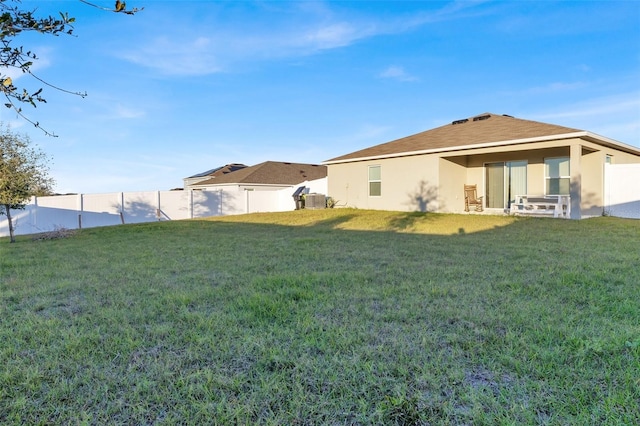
xmin=0 ymin=127 xmax=53 ymax=242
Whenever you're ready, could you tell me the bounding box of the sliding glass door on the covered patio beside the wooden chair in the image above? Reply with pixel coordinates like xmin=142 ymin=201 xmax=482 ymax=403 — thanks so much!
xmin=485 ymin=161 xmax=527 ymax=209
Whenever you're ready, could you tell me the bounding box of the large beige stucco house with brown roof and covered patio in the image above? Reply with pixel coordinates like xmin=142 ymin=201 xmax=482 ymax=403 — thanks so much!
xmin=323 ymin=113 xmax=640 ymax=219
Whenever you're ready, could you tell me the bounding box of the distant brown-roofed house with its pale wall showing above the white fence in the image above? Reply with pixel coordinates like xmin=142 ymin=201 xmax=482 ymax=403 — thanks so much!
xmin=190 ymin=161 xmax=327 ymax=191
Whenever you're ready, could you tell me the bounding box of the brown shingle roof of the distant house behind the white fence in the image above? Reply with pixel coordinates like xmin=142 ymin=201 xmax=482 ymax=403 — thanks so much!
xmin=197 ymin=161 xmax=327 ymax=186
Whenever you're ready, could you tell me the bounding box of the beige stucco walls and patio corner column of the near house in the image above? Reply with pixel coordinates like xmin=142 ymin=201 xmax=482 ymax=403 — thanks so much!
xmin=328 ymin=138 xmax=640 ymax=219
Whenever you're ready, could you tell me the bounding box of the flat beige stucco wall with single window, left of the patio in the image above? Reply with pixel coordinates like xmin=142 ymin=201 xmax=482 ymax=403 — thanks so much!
xmin=328 ymin=155 xmax=439 ymax=211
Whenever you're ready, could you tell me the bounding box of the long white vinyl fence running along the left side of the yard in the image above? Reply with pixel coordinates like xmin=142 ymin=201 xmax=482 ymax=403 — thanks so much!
xmin=0 ymin=178 xmax=327 ymax=237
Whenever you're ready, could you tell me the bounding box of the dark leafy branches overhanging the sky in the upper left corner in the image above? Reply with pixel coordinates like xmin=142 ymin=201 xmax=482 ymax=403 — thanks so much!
xmin=0 ymin=0 xmax=141 ymax=136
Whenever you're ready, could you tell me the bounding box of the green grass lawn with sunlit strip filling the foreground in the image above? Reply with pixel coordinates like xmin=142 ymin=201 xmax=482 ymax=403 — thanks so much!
xmin=0 ymin=209 xmax=640 ymax=425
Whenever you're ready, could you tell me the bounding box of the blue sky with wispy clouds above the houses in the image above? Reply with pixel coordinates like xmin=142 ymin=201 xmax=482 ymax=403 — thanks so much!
xmin=0 ymin=0 xmax=640 ymax=193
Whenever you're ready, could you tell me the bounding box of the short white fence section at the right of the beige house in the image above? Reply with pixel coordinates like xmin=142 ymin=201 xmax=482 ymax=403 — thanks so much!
xmin=604 ymin=164 xmax=640 ymax=219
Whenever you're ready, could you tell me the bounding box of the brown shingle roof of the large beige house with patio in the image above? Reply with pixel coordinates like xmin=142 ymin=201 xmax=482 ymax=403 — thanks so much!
xmin=327 ymin=113 xmax=582 ymax=162
